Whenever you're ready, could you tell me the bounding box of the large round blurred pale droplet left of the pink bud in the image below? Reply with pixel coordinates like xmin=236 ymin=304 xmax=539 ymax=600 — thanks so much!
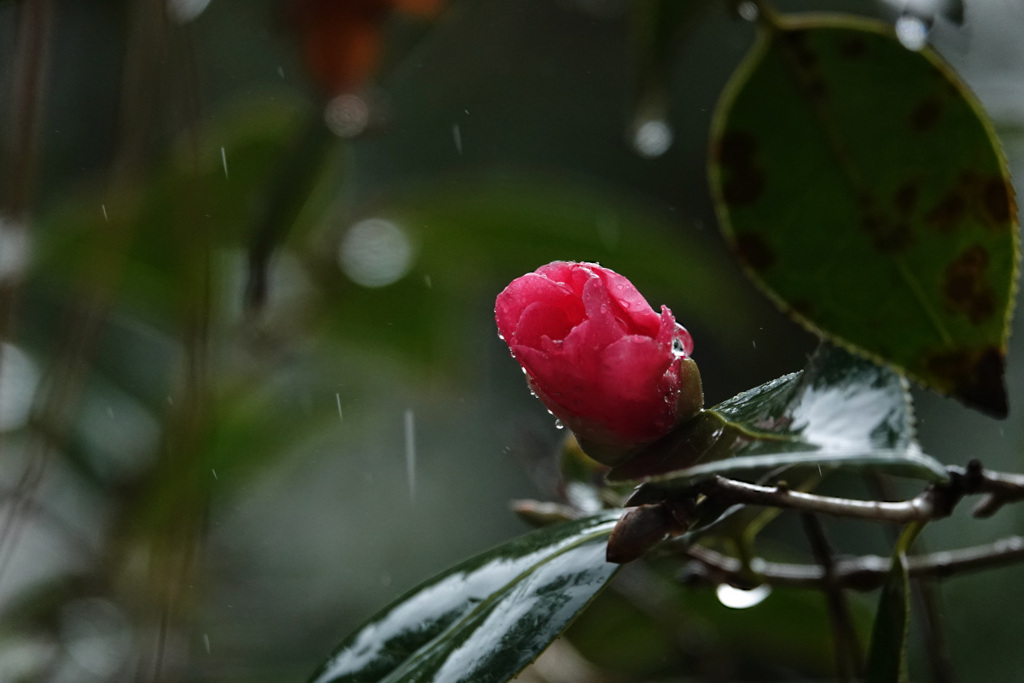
xmin=339 ymin=218 xmax=413 ymax=287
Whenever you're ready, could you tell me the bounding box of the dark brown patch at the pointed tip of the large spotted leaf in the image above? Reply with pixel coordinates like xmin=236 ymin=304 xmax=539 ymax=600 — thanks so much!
xmin=925 ymin=346 xmax=1010 ymax=418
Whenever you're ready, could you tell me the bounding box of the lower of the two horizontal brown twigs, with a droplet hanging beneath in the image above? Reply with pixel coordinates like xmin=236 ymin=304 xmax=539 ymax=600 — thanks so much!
xmin=685 ymin=536 xmax=1024 ymax=591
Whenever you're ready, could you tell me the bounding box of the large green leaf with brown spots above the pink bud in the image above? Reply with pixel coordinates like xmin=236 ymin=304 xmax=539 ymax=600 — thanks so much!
xmin=709 ymin=15 xmax=1020 ymax=417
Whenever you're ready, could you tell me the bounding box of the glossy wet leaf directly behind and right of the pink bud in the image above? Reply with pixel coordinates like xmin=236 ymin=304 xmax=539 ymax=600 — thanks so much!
xmin=608 ymin=344 xmax=948 ymax=489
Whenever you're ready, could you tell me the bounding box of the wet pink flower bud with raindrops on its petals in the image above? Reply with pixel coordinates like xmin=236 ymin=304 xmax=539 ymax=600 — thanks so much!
xmin=495 ymin=261 xmax=703 ymax=465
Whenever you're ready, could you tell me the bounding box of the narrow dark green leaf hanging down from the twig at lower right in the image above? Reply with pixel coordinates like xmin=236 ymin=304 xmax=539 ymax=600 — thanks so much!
xmin=864 ymin=524 xmax=923 ymax=683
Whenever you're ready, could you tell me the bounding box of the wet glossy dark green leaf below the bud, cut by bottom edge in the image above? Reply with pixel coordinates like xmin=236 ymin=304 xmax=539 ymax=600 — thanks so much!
xmin=311 ymin=511 xmax=621 ymax=683
